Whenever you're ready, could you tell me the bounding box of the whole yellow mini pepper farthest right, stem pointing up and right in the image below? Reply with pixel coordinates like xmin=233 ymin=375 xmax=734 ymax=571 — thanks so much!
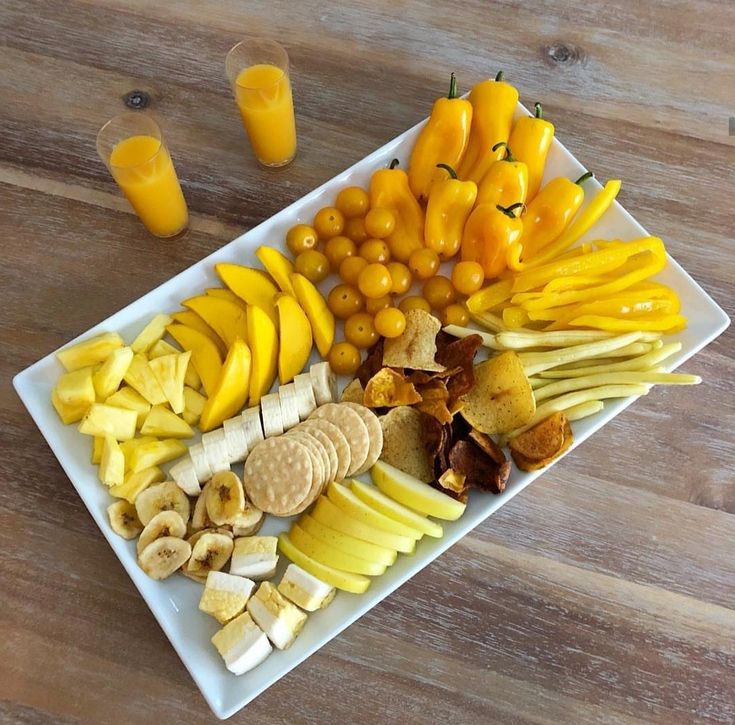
xmin=520 ymin=171 xmax=592 ymax=259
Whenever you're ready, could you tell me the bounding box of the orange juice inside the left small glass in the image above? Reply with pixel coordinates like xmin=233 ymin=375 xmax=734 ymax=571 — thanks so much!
xmin=110 ymin=136 xmax=189 ymax=237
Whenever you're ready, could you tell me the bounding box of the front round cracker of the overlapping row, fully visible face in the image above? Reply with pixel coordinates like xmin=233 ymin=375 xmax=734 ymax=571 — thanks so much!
xmin=243 ymin=436 xmax=313 ymax=516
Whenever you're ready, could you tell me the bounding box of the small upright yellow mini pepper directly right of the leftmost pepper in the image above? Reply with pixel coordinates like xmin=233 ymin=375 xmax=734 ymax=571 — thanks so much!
xmin=424 ymin=164 xmax=477 ymax=261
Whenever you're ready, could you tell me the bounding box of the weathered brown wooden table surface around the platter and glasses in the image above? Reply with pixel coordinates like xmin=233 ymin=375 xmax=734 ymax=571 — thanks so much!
xmin=0 ymin=0 xmax=735 ymax=723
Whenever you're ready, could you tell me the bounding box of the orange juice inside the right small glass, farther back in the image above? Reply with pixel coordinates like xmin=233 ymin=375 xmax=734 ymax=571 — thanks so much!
xmin=235 ymin=63 xmax=296 ymax=166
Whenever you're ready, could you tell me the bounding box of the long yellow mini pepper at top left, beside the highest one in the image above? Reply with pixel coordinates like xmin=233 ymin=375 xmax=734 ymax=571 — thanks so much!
xmin=408 ymin=73 xmax=472 ymax=202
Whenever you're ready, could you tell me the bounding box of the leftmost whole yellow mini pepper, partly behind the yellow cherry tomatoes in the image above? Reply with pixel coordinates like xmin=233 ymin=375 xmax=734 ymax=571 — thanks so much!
xmin=370 ymin=159 xmax=424 ymax=262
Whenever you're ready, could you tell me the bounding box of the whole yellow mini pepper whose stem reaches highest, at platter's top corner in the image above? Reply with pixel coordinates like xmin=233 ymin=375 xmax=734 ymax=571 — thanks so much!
xmin=458 ymin=71 xmax=518 ymax=182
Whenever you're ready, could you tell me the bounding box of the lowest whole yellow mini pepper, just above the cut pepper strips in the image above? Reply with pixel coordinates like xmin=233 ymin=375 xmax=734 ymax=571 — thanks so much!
xmin=462 ymin=202 xmax=523 ymax=279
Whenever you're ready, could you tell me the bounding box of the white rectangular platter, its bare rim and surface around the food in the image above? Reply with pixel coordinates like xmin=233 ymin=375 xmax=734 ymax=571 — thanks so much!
xmin=14 ymin=105 xmax=730 ymax=719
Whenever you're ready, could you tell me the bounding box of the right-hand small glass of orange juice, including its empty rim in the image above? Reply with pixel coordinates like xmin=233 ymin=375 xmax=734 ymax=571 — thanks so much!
xmin=225 ymin=39 xmax=296 ymax=166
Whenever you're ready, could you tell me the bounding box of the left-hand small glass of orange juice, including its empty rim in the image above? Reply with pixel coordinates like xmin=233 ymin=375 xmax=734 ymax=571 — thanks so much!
xmin=97 ymin=111 xmax=189 ymax=237
